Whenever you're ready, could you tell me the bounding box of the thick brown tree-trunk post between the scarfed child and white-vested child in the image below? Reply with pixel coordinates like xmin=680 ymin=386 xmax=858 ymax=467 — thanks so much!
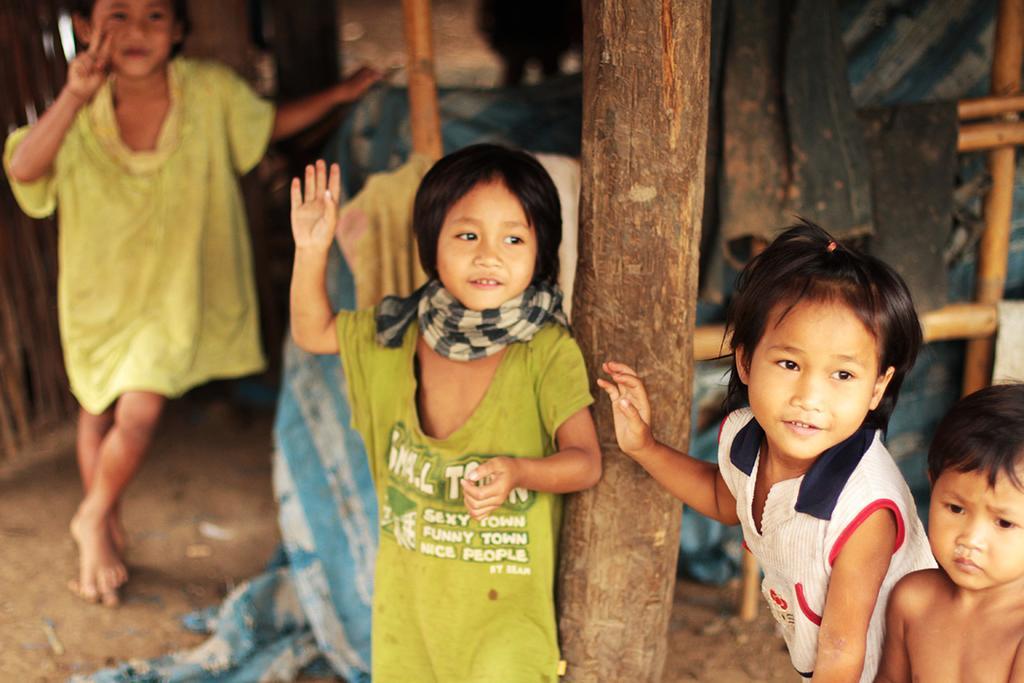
xmin=558 ymin=0 xmax=711 ymax=681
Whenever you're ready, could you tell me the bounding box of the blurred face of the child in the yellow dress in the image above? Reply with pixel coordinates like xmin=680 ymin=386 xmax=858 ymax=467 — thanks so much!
xmin=82 ymin=0 xmax=183 ymax=78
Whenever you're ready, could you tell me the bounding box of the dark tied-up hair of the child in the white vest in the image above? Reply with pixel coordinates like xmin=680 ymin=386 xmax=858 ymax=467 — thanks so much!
xmin=726 ymin=220 xmax=922 ymax=429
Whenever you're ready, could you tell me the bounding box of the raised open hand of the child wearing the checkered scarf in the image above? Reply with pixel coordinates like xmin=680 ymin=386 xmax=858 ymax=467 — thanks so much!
xmin=292 ymin=159 xmax=341 ymax=251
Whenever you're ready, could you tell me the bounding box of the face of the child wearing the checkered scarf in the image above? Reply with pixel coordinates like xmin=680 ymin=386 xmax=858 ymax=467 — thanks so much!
xmin=437 ymin=180 xmax=537 ymax=310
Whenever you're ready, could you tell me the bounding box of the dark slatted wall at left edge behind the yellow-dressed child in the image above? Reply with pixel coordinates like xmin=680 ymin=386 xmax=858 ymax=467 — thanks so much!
xmin=0 ymin=0 xmax=76 ymax=462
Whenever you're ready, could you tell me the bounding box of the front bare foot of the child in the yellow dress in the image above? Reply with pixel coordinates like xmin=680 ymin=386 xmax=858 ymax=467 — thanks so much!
xmin=69 ymin=508 xmax=128 ymax=607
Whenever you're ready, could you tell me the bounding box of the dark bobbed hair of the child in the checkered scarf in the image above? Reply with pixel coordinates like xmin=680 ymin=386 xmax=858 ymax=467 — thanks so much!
xmin=413 ymin=143 xmax=562 ymax=284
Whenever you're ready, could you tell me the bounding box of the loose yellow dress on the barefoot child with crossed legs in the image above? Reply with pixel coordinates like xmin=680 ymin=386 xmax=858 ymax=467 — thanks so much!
xmin=3 ymin=58 xmax=274 ymax=414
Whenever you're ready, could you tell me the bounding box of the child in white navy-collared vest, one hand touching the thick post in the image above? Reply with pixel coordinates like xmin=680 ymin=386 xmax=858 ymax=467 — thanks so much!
xmin=598 ymin=222 xmax=935 ymax=681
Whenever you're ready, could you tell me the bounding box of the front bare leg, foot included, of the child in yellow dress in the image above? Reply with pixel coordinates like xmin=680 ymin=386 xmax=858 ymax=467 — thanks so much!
xmin=71 ymin=391 xmax=166 ymax=605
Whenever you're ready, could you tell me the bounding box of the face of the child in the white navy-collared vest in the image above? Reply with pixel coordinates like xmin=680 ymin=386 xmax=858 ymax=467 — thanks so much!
xmin=736 ymin=302 xmax=893 ymax=472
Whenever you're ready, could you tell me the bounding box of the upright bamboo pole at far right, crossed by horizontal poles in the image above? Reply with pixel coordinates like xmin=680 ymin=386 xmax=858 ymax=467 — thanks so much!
xmin=964 ymin=0 xmax=1024 ymax=395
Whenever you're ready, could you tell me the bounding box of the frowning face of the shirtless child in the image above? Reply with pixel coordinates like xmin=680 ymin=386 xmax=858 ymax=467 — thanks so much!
xmin=928 ymin=470 xmax=1024 ymax=592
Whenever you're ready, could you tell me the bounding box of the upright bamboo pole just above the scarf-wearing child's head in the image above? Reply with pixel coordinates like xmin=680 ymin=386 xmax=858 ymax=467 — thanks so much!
xmin=401 ymin=0 xmax=444 ymax=159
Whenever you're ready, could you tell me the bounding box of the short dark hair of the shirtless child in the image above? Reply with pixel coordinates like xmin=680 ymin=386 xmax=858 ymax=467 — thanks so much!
xmin=928 ymin=384 xmax=1024 ymax=490
